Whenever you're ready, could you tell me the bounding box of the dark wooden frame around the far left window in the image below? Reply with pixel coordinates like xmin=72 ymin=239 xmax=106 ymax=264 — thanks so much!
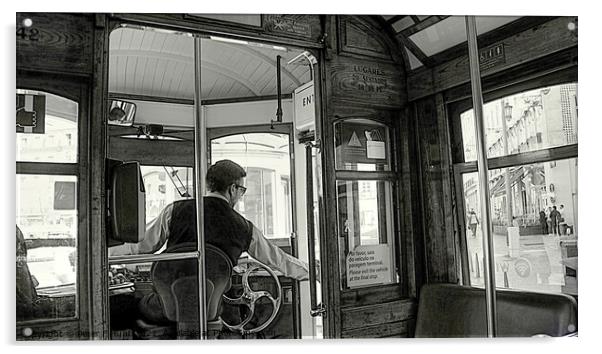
xmin=16 ymin=70 xmax=94 ymax=340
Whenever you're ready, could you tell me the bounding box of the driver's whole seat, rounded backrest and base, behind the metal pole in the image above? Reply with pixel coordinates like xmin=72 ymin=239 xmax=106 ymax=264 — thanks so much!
xmin=137 ymin=242 xmax=233 ymax=339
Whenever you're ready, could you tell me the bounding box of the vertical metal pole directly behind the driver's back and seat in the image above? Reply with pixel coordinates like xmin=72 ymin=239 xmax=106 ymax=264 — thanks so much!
xmin=194 ymin=37 xmax=207 ymax=339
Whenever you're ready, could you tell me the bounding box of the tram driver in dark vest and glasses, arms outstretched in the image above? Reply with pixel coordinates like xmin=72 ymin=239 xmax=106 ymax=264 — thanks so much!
xmin=110 ymin=160 xmax=308 ymax=323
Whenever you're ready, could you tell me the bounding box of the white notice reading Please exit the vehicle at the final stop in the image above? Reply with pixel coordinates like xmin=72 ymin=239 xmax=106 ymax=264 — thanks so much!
xmin=346 ymin=244 xmax=392 ymax=288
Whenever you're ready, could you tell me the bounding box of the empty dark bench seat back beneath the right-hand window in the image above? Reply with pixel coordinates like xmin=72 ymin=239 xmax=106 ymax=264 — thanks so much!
xmin=414 ymin=284 xmax=577 ymax=338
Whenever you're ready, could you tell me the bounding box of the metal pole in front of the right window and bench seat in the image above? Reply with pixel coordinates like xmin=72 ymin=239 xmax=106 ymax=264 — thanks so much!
xmin=466 ymin=16 xmax=497 ymax=337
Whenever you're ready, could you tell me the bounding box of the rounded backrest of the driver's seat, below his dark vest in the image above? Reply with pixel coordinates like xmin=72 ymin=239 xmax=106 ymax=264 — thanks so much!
xmin=151 ymin=243 xmax=233 ymax=325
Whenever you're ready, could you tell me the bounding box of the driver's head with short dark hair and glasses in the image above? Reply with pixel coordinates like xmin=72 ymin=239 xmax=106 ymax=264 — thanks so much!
xmin=205 ymin=160 xmax=247 ymax=207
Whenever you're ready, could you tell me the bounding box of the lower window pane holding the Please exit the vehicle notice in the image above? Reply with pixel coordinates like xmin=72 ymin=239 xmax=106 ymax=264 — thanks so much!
xmin=337 ymin=180 xmax=397 ymax=288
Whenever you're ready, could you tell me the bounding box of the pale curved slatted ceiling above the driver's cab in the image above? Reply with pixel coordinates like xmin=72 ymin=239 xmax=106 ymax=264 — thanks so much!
xmin=109 ymin=27 xmax=310 ymax=100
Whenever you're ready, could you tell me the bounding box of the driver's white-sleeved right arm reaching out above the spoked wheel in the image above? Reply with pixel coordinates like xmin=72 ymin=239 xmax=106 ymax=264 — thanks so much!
xmin=248 ymin=225 xmax=309 ymax=280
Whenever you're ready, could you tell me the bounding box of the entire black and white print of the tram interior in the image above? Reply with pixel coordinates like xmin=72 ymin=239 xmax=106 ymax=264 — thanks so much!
xmin=4 ymin=2 xmax=600 ymax=352
